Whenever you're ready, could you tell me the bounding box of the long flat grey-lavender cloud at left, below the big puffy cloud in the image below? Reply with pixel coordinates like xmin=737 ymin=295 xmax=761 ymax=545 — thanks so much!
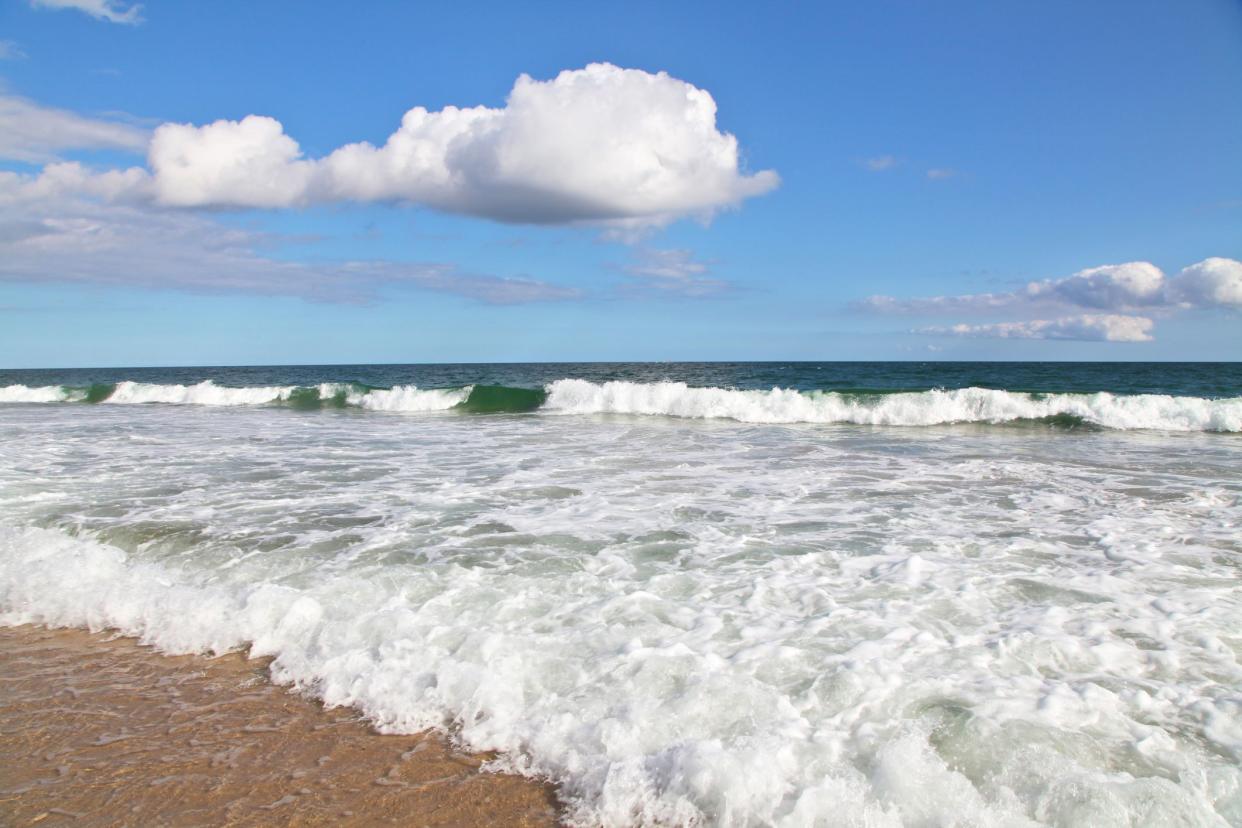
xmin=0 ymin=178 xmax=580 ymax=304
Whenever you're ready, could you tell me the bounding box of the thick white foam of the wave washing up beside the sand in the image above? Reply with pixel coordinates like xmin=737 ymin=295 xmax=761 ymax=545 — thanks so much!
xmin=0 ymin=508 xmax=1242 ymax=827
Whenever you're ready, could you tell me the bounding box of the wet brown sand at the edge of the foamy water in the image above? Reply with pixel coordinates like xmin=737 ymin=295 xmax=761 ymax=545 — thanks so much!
xmin=0 ymin=627 xmax=558 ymax=826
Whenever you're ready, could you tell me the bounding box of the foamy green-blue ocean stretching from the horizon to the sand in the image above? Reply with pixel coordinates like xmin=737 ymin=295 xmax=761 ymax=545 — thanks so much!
xmin=0 ymin=362 xmax=1242 ymax=826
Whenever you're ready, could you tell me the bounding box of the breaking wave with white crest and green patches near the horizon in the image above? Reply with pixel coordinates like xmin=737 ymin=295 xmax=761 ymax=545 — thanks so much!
xmin=0 ymin=379 xmax=1242 ymax=432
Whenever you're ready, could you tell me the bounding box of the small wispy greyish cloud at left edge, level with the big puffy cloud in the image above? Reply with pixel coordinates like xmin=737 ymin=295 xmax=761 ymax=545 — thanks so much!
xmin=0 ymin=96 xmax=149 ymax=163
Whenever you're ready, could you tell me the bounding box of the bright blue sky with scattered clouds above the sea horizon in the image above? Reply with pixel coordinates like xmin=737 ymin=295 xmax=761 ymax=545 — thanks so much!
xmin=0 ymin=0 xmax=1242 ymax=367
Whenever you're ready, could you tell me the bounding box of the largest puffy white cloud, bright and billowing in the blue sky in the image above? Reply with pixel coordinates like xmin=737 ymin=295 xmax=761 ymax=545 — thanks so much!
xmin=150 ymin=63 xmax=779 ymax=227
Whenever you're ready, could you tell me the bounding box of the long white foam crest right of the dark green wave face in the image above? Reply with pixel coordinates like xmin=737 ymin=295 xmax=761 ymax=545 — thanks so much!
xmin=545 ymin=380 xmax=1242 ymax=432
